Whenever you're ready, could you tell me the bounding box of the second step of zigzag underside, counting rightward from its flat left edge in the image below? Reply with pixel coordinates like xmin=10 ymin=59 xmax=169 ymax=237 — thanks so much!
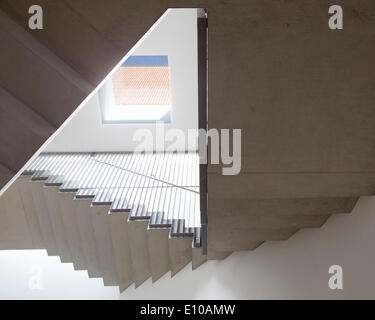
xmin=43 ymin=187 xmax=73 ymax=262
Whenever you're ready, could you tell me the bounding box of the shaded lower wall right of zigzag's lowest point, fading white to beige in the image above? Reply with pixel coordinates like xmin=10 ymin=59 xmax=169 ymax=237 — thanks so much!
xmin=121 ymin=197 xmax=375 ymax=299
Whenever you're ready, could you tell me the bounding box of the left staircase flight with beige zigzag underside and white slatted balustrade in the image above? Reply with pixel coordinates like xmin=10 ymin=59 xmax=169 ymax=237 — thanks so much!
xmin=10 ymin=153 xmax=207 ymax=291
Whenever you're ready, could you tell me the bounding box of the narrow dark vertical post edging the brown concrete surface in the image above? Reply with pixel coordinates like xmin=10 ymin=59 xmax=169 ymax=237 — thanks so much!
xmin=197 ymin=12 xmax=208 ymax=254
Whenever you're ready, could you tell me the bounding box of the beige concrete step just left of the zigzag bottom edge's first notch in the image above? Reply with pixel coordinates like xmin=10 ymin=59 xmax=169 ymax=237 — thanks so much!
xmin=16 ymin=175 xmax=45 ymax=249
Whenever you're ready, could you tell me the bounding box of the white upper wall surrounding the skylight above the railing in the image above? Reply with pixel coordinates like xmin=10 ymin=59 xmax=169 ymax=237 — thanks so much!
xmin=45 ymin=9 xmax=198 ymax=151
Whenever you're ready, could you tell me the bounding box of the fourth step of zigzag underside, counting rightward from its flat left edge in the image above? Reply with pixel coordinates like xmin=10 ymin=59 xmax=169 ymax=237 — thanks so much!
xmin=74 ymin=199 xmax=102 ymax=278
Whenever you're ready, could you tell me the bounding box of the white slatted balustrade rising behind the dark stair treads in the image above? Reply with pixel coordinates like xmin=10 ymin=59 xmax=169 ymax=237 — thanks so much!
xmin=24 ymin=153 xmax=200 ymax=235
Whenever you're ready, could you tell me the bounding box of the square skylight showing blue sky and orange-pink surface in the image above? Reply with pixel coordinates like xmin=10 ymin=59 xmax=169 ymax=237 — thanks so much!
xmin=101 ymin=55 xmax=171 ymax=123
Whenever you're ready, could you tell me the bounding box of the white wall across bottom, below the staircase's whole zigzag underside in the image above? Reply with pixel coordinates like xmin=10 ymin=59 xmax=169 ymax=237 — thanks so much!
xmin=0 ymin=197 xmax=375 ymax=299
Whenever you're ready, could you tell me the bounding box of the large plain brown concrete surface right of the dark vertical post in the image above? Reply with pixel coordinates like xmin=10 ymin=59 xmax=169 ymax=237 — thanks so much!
xmin=204 ymin=0 xmax=375 ymax=250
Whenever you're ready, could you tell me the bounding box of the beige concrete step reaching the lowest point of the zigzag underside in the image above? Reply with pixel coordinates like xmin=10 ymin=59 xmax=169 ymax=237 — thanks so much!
xmin=109 ymin=212 xmax=134 ymax=292
